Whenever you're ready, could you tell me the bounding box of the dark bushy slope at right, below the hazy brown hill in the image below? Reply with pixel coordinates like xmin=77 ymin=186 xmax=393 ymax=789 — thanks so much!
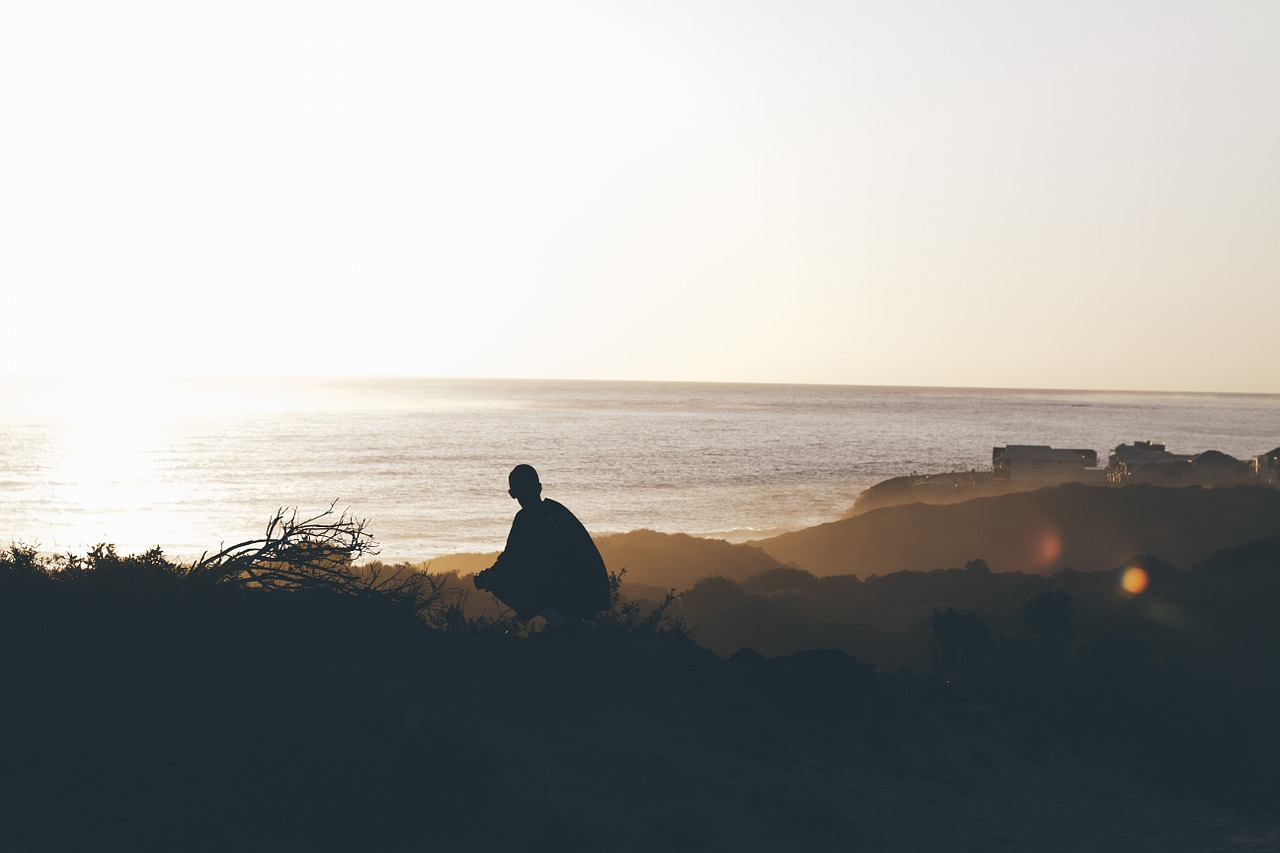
xmin=681 ymin=537 xmax=1280 ymax=797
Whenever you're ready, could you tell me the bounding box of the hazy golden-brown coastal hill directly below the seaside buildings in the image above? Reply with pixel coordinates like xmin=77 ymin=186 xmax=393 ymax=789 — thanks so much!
xmin=753 ymin=484 xmax=1280 ymax=576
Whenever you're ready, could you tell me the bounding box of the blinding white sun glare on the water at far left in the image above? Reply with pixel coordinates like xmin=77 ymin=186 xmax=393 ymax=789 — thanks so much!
xmin=5 ymin=373 xmax=391 ymax=553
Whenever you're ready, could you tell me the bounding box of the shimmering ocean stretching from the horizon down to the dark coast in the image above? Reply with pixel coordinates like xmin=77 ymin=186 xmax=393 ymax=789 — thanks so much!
xmin=0 ymin=379 xmax=1280 ymax=562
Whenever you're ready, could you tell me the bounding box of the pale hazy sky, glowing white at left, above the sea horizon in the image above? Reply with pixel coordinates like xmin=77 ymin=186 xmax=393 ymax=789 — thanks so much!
xmin=0 ymin=0 xmax=1280 ymax=392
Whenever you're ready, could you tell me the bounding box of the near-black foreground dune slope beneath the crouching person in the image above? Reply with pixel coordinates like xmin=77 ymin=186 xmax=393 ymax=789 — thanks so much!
xmin=0 ymin=539 xmax=1280 ymax=853
